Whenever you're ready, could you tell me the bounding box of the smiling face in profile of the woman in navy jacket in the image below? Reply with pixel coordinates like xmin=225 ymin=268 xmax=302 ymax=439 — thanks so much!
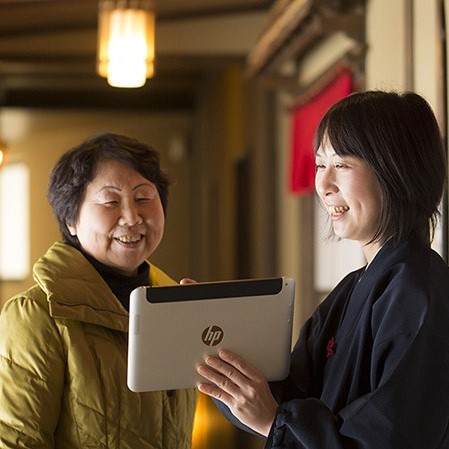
xmin=315 ymin=139 xmax=381 ymax=259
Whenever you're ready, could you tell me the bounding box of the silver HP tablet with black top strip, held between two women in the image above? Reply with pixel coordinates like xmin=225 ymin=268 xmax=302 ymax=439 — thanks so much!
xmin=127 ymin=277 xmax=295 ymax=392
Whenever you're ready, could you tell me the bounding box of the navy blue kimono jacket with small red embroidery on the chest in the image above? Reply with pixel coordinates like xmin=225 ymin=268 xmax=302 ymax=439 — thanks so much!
xmin=219 ymin=242 xmax=449 ymax=449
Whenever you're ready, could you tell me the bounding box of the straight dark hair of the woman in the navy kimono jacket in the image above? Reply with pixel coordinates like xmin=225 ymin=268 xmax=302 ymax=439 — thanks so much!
xmin=314 ymin=91 xmax=447 ymax=244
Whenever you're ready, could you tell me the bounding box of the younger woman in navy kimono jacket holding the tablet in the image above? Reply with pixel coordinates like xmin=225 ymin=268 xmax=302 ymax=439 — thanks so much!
xmin=198 ymin=92 xmax=449 ymax=449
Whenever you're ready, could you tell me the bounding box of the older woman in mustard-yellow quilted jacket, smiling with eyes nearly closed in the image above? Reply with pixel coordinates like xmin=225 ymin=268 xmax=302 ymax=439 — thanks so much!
xmin=0 ymin=134 xmax=195 ymax=449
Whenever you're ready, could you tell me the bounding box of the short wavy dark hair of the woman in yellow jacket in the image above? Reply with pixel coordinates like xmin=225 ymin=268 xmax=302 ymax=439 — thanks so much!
xmin=47 ymin=133 xmax=169 ymax=246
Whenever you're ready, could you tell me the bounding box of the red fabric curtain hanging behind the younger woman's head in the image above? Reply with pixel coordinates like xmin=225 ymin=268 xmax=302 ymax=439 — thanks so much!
xmin=290 ymin=71 xmax=352 ymax=194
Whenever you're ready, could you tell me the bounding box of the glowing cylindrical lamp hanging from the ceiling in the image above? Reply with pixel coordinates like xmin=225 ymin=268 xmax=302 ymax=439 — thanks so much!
xmin=97 ymin=0 xmax=155 ymax=87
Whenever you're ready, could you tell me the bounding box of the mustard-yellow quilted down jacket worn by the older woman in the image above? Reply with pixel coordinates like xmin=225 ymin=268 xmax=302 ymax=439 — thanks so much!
xmin=0 ymin=242 xmax=196 ymax=449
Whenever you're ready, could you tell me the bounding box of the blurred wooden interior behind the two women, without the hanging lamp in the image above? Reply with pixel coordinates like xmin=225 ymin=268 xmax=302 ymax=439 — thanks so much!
xmin=0 ymin=0 xmax=447 ymax=449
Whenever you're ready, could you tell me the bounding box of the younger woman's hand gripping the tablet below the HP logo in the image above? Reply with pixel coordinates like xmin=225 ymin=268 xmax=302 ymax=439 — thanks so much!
xmin=197 ymin=350 xmax=279 ymax=436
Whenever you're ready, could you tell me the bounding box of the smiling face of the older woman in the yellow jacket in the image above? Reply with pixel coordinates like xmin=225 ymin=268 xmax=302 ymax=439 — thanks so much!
xmin=67 ymin=160 xmax=165 ymax=276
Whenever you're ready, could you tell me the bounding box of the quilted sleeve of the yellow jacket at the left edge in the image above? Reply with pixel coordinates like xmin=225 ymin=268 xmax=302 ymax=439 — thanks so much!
xmin=0 ymin=296 xmax=64 ymax=449
